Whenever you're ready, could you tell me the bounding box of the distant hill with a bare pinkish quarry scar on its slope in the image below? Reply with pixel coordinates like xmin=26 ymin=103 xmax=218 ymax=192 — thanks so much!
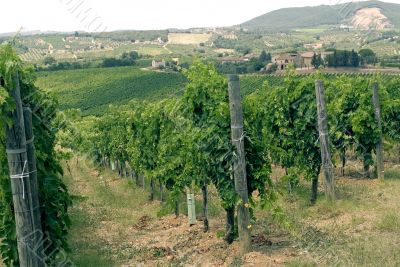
xmin=241 ymin=1 xmax=400 ymax=30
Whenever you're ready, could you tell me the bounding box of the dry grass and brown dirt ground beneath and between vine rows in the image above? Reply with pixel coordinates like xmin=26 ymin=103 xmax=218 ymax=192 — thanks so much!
xmin=64 ymin=160 xmax=400 ymax=267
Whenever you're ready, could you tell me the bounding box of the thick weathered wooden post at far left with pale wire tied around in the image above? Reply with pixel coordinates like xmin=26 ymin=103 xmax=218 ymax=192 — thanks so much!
xmin=5 ymin=75 xmax=39 ymax=266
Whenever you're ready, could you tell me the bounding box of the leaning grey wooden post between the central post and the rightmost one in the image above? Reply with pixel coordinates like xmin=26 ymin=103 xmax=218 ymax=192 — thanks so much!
xmin=315 ymin=80 xmax=335 ymax=201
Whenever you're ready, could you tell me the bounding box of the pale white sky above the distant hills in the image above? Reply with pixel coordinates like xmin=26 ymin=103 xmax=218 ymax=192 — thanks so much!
xmin=0 ymin=0 xmax=400 ymax=33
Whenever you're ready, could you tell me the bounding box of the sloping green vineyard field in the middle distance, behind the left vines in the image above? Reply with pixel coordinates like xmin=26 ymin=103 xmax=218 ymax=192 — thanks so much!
xmin=36 ymin=67 xmax=186 ymax=115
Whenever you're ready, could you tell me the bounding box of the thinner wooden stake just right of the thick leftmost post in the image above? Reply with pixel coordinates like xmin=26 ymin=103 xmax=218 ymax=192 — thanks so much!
xmin=23 ymin=107 xmax=45 ymax=266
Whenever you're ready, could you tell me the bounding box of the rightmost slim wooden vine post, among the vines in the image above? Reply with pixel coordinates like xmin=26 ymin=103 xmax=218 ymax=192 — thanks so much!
xmin=372 ymin=82 xmax=385 ymax=180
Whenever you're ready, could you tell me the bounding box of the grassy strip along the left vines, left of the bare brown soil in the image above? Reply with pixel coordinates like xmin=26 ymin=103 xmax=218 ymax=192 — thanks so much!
xmin=65 ymin=161 xmax=159 ymax=266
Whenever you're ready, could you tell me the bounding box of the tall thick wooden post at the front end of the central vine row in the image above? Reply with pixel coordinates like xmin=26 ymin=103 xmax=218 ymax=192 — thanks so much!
xmin=228 ymin=75 xmax=251 ymax=254
